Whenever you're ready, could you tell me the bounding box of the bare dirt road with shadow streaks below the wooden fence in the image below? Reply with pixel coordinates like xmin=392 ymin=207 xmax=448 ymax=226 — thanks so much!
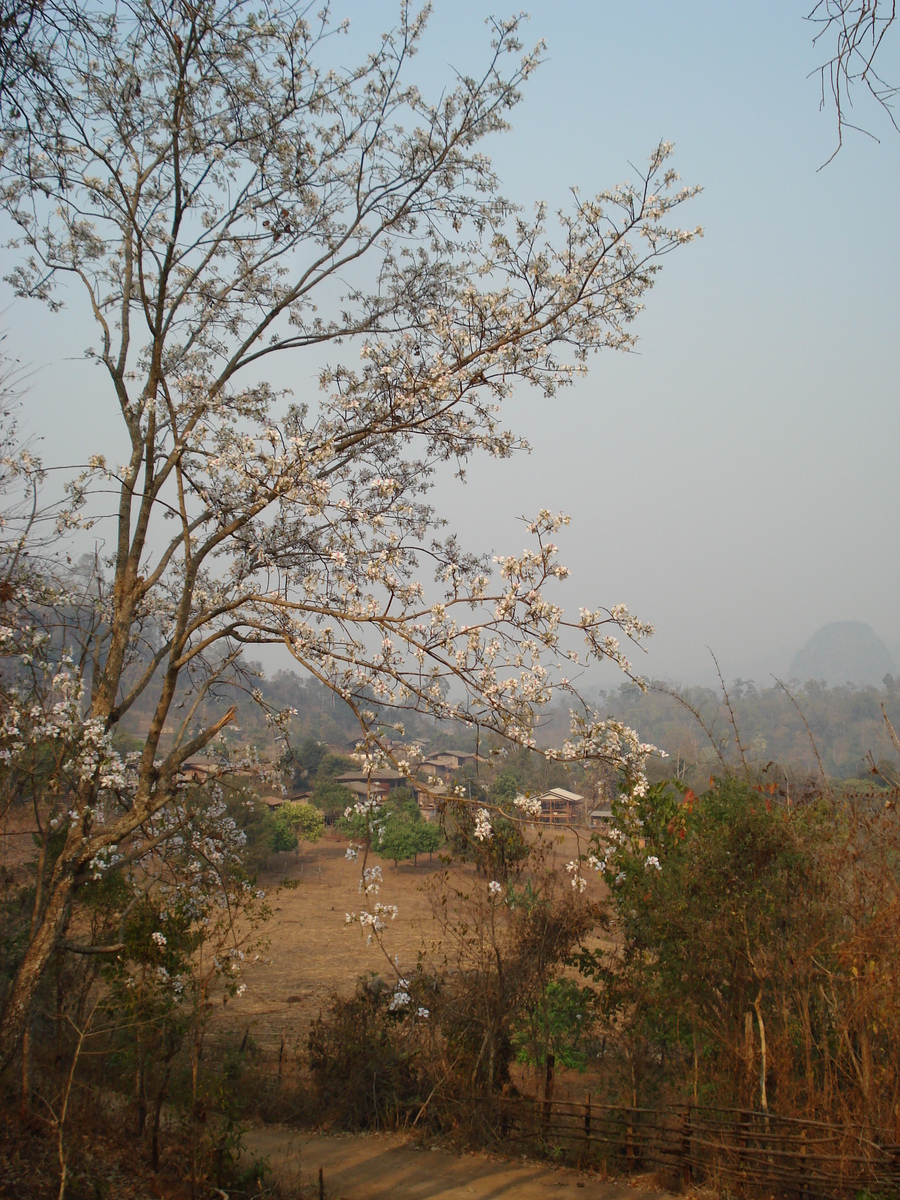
xmin=246 ymin=1126 xmax=667 ymax=1200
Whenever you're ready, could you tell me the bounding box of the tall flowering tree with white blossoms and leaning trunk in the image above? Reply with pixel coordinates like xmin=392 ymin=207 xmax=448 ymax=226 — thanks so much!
xmin=0 ymin=0 xmax=696 ymax=1062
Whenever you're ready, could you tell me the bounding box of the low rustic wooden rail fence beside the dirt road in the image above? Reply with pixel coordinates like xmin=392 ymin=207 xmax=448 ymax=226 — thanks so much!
xmin=493 ymin=1097 xmax=900 ymax=1200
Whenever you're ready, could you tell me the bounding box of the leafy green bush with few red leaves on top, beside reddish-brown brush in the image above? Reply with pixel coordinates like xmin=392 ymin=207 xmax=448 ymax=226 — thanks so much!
xmin=588 ymin=780 xmax=812 ymax=1065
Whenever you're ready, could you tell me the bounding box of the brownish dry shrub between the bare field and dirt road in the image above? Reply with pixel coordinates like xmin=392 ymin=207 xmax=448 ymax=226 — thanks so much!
xmin=308 ymin=830 xmax=600 ymax=1130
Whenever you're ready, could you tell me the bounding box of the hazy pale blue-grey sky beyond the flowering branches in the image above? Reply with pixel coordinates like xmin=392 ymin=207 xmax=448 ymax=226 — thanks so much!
xmin=4 ymin=0 xmax=900 ymax=684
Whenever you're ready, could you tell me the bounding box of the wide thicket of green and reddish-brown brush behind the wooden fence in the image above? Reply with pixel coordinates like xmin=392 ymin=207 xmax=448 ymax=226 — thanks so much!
xmin=580 ymin=776 xmax=900 ymax=1129
